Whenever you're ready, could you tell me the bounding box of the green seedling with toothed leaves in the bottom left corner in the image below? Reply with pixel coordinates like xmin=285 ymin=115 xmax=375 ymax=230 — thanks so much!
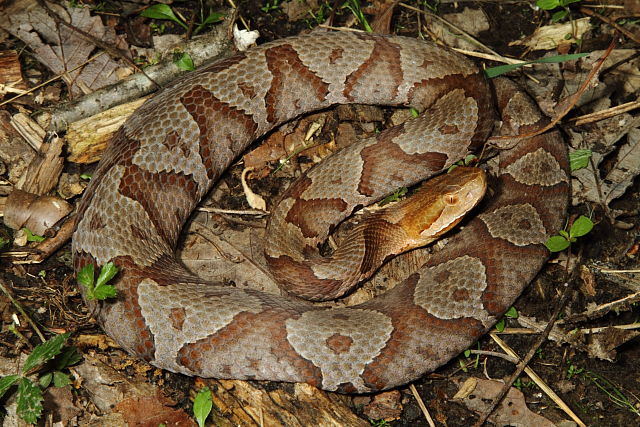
xmin=0 ymin=333 xmax=81 ymax=424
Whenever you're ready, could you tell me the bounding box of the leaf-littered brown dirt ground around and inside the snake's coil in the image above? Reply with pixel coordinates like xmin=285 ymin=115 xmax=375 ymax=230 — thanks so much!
xmin=0 ymin=0 xmax=640 ymax=426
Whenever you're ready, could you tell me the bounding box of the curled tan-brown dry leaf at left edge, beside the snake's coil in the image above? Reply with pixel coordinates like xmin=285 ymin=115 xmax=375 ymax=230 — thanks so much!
xmin=4 ymin=189 xmax=72 ymax=235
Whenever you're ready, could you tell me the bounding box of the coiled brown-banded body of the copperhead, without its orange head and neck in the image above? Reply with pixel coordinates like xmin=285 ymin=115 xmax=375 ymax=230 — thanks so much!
xmin=72 ymin=33 xmax=569 ymax=392
